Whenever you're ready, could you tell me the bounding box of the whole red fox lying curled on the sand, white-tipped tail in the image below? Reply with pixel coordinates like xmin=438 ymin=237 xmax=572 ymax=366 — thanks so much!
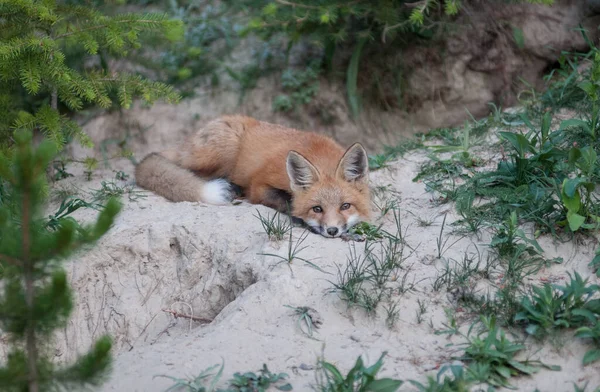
xmin=135 ymin=116 xmax=371 ymax=237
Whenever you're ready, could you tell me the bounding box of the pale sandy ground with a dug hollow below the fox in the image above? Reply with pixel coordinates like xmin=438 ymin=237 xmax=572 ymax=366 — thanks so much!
xmin=38 ymin=119 xmax=600 ymax=391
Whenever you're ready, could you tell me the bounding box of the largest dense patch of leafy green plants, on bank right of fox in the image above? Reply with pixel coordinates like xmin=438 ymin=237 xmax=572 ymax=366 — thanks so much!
xmin=414 ymin=49 xmax=600 ymax=247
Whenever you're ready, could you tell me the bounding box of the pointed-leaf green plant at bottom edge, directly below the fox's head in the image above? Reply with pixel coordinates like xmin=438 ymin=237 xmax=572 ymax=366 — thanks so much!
xmin=316 ymin=352 xmax=403 ymax=392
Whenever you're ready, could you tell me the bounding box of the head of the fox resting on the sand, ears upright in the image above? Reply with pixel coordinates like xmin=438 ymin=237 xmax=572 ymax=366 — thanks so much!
xmin=286 ymin=143 xmax=371 ymax=237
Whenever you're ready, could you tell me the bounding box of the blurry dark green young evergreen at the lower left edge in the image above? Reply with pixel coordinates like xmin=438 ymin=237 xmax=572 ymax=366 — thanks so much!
xmin=0 ymin=131 xmax=120 ymax=392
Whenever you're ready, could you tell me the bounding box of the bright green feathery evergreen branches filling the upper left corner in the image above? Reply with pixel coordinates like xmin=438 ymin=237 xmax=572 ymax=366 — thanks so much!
xmin=0 ymin=0 xmax=183 ymax=148
